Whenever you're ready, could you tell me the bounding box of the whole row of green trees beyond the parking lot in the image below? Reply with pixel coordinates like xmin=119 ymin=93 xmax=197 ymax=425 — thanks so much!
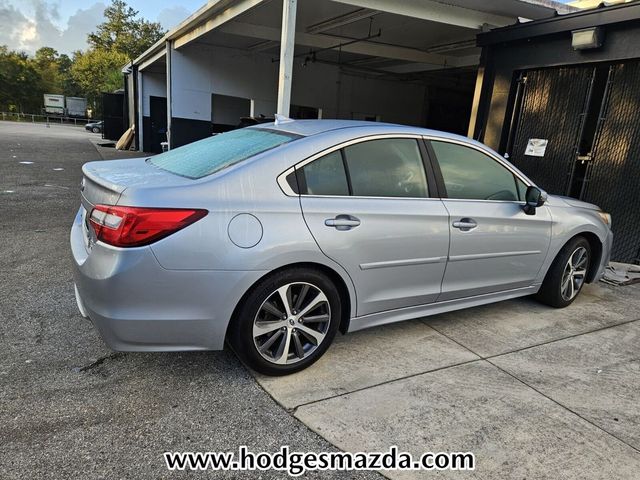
xmin=0 ymin=0 xmax=165 ymax=115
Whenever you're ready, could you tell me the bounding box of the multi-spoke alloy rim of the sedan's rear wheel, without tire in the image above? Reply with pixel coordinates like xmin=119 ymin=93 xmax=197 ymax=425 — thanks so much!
xmin=253 ymin=282 xmax=331 ymax=365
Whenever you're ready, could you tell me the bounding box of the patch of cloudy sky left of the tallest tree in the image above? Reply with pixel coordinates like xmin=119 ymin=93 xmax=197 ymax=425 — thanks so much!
xmin=0 ymin=0 xmax=105 ymax=54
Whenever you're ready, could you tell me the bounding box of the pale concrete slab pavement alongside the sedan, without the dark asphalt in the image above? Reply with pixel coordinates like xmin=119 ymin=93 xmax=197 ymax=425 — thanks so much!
xmin=257 ymin=284 xmax=640 ymax=479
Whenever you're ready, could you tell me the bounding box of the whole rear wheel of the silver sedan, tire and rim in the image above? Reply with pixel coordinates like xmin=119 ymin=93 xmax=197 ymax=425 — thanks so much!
xmin=229 ymin=268 xmax=342 ymax=376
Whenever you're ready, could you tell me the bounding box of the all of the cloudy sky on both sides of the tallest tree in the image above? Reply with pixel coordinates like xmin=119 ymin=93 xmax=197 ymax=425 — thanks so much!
xmin=0 ymin=0 xmax=206 ymax=54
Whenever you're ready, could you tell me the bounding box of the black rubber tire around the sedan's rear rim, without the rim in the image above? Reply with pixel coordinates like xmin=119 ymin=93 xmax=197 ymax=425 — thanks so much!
xmin=230 ymin=268 xmax=342 ymax=375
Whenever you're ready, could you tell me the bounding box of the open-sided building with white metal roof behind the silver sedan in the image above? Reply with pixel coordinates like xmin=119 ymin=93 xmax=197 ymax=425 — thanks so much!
xmin=130 ymin=0 xmax=569 ymax=147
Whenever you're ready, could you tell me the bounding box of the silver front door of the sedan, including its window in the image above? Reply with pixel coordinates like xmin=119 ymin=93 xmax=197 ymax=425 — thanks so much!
xmin=428 ymin=139 xmax=551 ymax=301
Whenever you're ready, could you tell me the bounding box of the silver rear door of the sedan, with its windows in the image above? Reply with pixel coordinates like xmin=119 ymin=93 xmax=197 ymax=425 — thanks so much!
xmin=296 ymin=136 xmax=449 ymax=316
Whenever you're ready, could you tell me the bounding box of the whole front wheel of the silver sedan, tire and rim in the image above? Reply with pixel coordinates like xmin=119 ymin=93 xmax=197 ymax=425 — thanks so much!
xmin=536 ymin=237 xmax=591 ymax=308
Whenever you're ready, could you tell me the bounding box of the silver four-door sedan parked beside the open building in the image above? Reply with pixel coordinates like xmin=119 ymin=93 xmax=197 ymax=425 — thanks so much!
xmin=71 ymin=119 xmax=613 ymax=375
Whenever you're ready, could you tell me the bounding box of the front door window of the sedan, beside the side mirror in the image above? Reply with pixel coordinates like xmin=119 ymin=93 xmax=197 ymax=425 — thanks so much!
xmin=431 ymin=140 xmax=524 ymax=201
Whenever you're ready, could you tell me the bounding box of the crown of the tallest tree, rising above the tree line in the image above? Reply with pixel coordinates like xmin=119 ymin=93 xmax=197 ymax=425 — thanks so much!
xmin=88 ymin=0 xmax=165 ymax=63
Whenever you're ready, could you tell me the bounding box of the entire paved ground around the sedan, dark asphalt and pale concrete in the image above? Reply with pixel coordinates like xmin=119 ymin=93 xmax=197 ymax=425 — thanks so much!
xmin=0 ymin=122 xmax=640 ymax=480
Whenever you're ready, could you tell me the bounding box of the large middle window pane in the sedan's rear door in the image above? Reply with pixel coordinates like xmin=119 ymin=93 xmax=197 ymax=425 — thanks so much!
xmin=344 ymin=138 xmax=427 ymax=197
